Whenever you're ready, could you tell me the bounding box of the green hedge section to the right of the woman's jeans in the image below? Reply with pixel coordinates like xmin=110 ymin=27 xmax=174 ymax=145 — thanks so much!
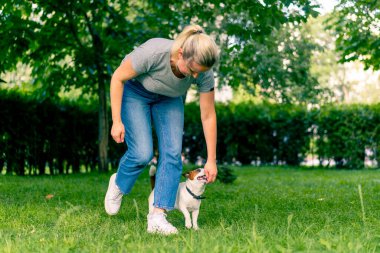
xmin=184 ymin=104 xmax=380 ymax=169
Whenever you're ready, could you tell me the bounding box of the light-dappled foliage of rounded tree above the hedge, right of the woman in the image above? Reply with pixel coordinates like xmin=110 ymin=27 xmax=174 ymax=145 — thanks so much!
xmin=226 ymin=22 xmax=326 ymax=104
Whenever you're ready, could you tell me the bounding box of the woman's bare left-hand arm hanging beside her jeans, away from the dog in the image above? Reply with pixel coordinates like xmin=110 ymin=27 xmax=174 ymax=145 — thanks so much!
xmin=110 ymin=58 xmax=137 ymax=143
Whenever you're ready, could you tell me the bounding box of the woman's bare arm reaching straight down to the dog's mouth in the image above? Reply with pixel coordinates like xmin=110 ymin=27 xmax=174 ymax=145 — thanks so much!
xmin=200 ymin=91 xmax=218 ymax=183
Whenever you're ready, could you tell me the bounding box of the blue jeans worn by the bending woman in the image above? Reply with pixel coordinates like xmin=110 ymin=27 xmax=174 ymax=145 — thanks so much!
xmin=116 ymin=80 xmax=184 ymax=210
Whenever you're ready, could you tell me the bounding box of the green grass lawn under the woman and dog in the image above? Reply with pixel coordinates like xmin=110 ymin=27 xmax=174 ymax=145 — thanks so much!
xmin=0 ymin=167 xmax=380 ymax=253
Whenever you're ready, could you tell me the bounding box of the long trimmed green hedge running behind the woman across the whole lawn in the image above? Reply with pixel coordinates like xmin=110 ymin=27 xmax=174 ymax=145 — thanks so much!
xmin=0 ymin=91 xmax=380 ymax=175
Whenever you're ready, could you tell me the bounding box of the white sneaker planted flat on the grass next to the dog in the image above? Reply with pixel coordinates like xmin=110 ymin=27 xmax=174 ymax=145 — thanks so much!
xmin=147 ymin=213 xmax=178 ymax=235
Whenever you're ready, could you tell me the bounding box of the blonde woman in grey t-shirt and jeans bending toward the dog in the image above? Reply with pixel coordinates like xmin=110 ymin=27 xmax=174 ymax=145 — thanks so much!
xmin=105 ymin=25 xmax=218 ymax=234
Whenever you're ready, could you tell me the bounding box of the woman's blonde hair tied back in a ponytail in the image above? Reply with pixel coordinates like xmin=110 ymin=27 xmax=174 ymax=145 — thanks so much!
xmin=172 ymin=25 xmax=219 ymax=68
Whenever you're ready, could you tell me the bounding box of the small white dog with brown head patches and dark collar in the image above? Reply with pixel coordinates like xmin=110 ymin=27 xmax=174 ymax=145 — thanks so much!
xmin=149 ymin=165 xmax=207 ymax=230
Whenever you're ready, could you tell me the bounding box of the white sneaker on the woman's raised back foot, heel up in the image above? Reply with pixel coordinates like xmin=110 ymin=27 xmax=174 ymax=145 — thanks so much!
xmin=104 ymin=173 xmax=123 ymax=215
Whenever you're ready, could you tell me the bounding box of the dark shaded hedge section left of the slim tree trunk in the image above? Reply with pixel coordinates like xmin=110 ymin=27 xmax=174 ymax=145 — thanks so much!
xmin=0 ymin=88 xmax=97 ymax=175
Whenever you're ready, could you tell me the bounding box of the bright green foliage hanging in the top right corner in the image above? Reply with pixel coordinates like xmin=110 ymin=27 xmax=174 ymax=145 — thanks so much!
xmin=330 ymin=0 xmax=380 ymax=70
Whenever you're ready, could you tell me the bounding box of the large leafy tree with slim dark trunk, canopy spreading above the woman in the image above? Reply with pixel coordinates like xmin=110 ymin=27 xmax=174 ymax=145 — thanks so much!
xmin=0 ymin=0 xmax=317 ymax=171
